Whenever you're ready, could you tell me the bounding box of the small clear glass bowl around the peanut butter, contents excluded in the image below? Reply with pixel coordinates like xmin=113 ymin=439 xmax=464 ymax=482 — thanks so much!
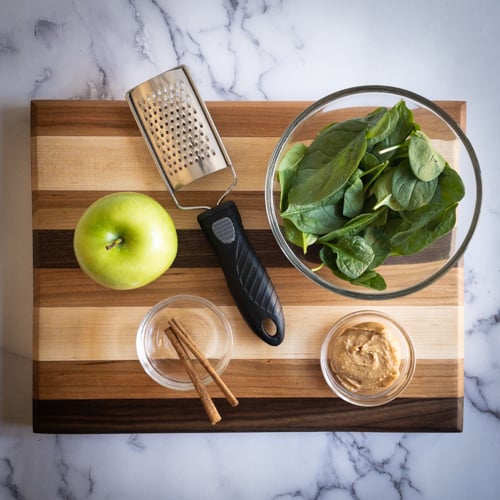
xmin=320 ymin=311 xmax=416 ymax=406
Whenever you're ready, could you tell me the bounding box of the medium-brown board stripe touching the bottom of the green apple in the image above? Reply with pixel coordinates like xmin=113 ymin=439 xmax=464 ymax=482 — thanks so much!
xmin=34 ymin=267 xmax=463 ymax=308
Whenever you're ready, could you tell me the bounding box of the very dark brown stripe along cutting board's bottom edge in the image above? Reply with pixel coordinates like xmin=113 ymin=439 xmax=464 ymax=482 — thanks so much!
xmin=33 ymin=398 xmax=463 ymax=433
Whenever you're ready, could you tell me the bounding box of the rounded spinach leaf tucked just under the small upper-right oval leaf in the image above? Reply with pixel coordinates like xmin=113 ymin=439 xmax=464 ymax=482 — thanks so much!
xmin=391 ymin=161 xmax=438 ymax=210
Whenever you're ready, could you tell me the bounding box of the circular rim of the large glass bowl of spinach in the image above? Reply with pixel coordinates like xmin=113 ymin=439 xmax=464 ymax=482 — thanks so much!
xmin=264 ymin=85 xmax=482 ymax=300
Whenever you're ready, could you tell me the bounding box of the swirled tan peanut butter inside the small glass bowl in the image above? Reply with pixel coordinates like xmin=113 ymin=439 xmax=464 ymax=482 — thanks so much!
xmin=330 ymin=322 xmax=401 ymax=392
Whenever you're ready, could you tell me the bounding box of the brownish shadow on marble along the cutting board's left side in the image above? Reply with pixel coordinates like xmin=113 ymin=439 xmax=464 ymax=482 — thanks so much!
xmin=0 ymin=104 xmax=33 ymax=425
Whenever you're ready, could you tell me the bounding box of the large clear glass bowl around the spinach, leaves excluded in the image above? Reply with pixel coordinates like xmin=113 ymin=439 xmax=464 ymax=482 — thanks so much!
xmin=265 ymin=86 xmax=482 ymax=299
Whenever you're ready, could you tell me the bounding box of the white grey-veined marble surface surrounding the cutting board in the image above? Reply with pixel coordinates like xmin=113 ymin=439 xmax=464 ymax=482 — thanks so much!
xmin=0 ymin=0 xmax=500 ymax=500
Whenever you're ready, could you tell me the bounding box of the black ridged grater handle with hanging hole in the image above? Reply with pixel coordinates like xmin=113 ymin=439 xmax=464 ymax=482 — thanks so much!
xmin=198 ymin=201 xmax=285 ymax=346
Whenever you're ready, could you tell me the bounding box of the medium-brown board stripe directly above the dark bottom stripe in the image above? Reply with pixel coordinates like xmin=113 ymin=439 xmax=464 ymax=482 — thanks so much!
xmin=34 ymin=359 xmax=463 ymax=400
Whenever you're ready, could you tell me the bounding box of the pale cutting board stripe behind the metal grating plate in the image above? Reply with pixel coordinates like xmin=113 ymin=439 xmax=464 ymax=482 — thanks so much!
xmin=32 ymin=136 xmax=278 ymax=194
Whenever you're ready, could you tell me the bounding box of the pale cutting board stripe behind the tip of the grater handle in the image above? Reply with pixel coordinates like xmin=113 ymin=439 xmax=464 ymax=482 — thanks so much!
xmin=34 ymin=305 xmax=463 ymax=361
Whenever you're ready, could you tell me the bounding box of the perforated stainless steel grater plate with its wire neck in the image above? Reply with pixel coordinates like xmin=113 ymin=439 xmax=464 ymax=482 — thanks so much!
xmin=125 ymin=66 xmax=237 ymax=209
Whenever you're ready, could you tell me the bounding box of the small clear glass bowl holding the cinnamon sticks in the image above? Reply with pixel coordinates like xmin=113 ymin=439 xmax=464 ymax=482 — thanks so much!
xmin=136 ymin=295 xmax=233 ymax=391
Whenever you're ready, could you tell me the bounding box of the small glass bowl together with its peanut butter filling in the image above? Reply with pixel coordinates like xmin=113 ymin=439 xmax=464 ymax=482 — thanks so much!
xmin=320 ymin=310 xmax=416 ymax=406
